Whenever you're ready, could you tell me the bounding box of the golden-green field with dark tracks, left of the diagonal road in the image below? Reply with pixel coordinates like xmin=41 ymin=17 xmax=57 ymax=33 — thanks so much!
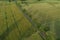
xmin=0 ymin=3 xmax=35 ymax=40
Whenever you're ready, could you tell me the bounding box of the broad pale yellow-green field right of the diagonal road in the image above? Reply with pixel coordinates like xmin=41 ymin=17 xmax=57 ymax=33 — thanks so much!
xmin=16 ymin=2 xmax=60 ymax=40
